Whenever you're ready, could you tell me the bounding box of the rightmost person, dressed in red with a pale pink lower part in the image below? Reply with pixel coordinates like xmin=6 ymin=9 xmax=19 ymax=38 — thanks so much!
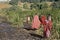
xmin=44 ymin=14 xmax=52 ymax=37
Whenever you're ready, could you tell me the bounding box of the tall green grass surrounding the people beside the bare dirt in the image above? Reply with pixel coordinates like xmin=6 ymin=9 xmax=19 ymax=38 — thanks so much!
xmin=0 ymin=3 xmax=60 ymax=40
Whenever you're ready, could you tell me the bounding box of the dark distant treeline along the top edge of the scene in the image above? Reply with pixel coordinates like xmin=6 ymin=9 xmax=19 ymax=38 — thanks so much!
xmin=10 ymin=0 xmax=60 ymax=4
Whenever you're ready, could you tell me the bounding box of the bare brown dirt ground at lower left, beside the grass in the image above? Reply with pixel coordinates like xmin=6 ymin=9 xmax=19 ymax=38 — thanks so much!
xmin=0 ymin=23 xmax=42 ymax=40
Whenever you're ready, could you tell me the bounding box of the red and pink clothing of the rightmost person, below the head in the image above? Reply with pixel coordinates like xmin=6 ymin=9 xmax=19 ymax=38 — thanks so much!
xmin=44 ymin=20 xmax=52 ymax=37
